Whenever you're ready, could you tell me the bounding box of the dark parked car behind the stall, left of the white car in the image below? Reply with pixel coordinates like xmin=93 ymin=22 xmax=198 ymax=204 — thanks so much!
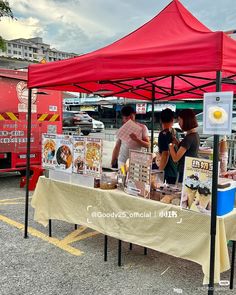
xmin=63 ymin=111 xmax=93 ymax=135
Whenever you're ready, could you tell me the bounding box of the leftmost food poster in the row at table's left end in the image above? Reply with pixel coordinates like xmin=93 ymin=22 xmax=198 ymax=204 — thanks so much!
xmin=42 ymin=134 xmax=57 ymax=169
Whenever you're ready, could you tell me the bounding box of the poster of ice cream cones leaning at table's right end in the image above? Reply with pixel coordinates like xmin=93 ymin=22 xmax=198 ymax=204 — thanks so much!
xmin=181 ymin=157 xmax=212 ymax=215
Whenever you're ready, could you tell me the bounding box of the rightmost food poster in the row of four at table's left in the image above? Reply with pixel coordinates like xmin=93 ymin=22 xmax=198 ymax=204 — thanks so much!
xmin=84 ymin=137 xmax=102 ymax=177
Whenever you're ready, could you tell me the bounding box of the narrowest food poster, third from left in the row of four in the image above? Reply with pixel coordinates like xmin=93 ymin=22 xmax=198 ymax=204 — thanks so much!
xmin=73 ymin=135 xmax=85 ymax=174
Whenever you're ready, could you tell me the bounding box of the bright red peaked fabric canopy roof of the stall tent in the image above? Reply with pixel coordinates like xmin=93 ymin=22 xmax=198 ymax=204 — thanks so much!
xmin=28 ymin=0 xmax=236 ymax=100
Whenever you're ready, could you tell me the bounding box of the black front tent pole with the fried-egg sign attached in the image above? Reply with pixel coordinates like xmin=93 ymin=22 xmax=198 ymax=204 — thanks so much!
xmin=208 ymin=71 xmax=222 ymax=295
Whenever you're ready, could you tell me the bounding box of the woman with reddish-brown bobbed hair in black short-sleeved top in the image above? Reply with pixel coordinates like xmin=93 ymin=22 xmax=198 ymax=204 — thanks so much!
xmin=169 ymin=109 xmax=200 ymax=183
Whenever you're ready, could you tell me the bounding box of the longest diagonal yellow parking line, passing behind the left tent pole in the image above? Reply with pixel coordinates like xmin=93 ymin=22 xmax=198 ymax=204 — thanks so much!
xmin=0 ymin=215 xmax=83 ymax=256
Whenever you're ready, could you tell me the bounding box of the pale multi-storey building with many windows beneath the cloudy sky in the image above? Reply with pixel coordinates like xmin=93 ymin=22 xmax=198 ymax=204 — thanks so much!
xmin=0 ymin=37 xmax=77 ymax=62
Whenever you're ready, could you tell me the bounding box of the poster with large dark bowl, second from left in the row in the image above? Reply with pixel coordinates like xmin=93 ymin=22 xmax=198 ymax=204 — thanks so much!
xmin=55 ymin=135 xmax=73 ymax=173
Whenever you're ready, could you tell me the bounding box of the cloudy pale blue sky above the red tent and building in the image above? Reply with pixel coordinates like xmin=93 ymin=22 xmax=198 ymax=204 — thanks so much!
xmin=0 ymin=0 xmax=236 ymax=53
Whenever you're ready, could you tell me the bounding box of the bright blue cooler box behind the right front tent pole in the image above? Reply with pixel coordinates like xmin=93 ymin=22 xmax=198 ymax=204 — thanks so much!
xmin=217 ymin=186 xmax=236 ymax=216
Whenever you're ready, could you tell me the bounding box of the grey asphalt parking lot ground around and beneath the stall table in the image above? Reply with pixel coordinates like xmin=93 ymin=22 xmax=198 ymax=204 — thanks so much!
xmin=0 ymin=174 xmax=236 ymax=295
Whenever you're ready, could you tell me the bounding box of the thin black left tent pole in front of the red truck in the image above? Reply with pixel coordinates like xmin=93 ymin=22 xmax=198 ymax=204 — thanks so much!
xmin=24 ymin=88 xmax=32 ymax=239
